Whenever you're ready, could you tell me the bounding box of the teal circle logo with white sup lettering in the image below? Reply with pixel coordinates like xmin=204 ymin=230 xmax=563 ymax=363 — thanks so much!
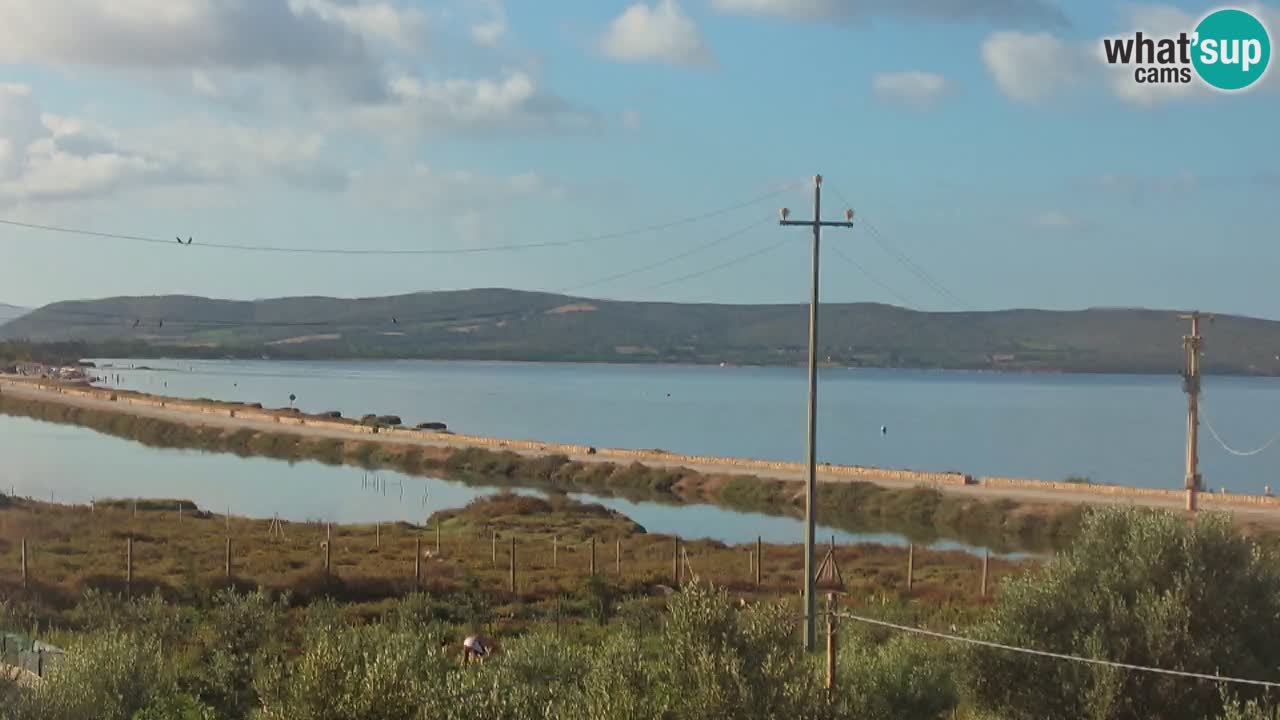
xmin=1192 ymin=9 xmax=1271 ymax=91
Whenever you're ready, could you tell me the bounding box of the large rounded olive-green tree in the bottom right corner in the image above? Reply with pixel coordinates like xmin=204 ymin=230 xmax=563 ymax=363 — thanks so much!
xmin=966 ymin=509 xmax=1280 ymax=720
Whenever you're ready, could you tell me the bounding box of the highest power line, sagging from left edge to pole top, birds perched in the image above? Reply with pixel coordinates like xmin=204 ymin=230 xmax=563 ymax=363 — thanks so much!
xmin=0 ymin=183 xmax=796 ymax=256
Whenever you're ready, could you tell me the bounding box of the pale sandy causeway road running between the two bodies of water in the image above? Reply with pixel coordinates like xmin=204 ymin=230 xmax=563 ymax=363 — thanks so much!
xmin=0 ymin=377 xmax=1280 ymax=525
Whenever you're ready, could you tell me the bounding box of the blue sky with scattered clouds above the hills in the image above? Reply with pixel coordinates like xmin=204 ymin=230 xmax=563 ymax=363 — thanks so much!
xmin=0 ymin=0 xmax=1280 ymax=318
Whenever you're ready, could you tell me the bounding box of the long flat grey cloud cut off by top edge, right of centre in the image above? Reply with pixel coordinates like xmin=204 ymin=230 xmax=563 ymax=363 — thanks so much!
xmin=712 ymin=0 xmax=1068 ymax=27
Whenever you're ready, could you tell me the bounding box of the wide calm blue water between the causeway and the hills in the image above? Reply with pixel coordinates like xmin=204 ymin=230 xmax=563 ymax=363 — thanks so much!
xmin=90 ymin=360 xmax=1280 ymax=492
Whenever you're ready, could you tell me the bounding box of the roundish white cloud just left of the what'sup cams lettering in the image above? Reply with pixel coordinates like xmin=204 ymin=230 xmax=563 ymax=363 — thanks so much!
xmin=980 ymin=31 xmax=1082 ymax=102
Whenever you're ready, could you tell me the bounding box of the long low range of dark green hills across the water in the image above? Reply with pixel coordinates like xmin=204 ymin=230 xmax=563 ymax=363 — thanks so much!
xmin=0 ymin=290 xmax=1280 ymax=375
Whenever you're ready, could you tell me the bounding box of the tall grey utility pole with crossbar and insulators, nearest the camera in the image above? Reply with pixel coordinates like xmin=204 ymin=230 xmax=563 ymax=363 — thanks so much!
xmin=780 ymin=176 xmax=854 ymax=651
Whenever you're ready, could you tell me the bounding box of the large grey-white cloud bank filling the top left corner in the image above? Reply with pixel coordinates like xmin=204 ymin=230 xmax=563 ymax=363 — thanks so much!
xmin=0 ymin=0 xmax=425 ymax=99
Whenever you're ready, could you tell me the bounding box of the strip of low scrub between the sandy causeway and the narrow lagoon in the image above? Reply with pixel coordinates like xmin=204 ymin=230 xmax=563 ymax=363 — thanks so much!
xmin=0 ymin=386 xmax=1080 ymax=551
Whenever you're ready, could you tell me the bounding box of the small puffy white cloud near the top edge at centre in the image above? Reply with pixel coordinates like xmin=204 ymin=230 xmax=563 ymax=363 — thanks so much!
xmin=600 ymin=0 xmax=714 ymax=65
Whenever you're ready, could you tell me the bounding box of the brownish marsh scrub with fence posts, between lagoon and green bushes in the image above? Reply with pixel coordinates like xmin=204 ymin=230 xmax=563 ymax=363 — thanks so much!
xmin=0 ymin=493 xmax=1032 ymax=619
